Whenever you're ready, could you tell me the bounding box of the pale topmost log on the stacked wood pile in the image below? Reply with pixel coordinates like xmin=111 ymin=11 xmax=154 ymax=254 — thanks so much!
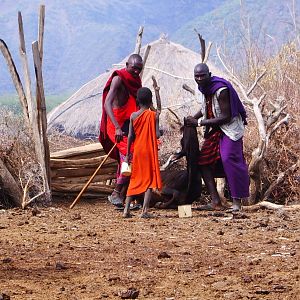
xmin=50 ymin=143 xmax=106 ymax=159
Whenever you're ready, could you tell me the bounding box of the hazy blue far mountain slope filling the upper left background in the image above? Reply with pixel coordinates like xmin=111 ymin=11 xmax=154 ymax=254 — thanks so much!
xmin=0 ymin=0 xmax=224 ymax=93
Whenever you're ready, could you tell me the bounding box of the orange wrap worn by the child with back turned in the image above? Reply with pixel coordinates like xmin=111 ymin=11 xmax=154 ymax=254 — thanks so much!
xmin=127 ymin=110 xmax=162 ymax=196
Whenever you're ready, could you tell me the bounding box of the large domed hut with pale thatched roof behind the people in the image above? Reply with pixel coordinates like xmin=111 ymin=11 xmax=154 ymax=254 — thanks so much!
xmin=48 ymin=38 xmax=220 ymax=138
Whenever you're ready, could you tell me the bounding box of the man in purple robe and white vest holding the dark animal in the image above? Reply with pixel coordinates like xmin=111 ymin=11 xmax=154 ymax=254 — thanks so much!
xmin=186 ymin=63 xmax=249 ymax=211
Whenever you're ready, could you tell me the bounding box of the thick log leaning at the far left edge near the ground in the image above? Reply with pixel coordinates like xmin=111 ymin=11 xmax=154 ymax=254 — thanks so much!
xmin=0 ymin=158 xmax=23 ymax=207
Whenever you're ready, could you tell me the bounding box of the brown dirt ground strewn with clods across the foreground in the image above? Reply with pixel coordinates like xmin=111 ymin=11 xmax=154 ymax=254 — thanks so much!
xmin=0 ymin=200 xmax=300 ymax=300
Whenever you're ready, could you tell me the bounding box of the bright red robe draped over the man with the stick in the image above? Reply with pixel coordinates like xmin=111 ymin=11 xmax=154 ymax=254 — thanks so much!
xmin=99 ymin=69 xmax=142 ymax=159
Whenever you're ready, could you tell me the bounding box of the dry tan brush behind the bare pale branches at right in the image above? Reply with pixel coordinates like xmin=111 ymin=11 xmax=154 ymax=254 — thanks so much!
xmin=243 ymin=42 xmax=300 ymax=204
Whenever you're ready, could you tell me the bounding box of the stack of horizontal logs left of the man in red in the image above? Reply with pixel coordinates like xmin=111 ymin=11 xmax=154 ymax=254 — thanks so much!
xmin=50 ymin=143 xmax=117 ymax=198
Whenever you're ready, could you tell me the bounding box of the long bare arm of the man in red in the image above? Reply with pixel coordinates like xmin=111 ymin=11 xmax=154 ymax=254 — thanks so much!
xmin=104 ymin=76 xmax=123 ymax=143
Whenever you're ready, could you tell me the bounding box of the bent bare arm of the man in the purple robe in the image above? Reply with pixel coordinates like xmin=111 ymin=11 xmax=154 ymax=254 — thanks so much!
xmin=200 ymin=89 xmax=231 ymax=126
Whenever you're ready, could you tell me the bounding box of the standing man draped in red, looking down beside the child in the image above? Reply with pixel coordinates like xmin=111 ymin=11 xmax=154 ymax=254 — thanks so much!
xmin=99 ymin=54 xmax=143 ymax=206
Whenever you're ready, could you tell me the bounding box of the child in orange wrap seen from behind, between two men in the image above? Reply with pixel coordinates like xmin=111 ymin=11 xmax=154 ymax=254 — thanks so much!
xmin=123 ymin=87 xmax=162 ymax=218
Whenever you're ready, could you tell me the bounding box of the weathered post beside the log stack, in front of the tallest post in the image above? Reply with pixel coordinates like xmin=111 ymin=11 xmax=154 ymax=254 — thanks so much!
xmin=32 ymin=41 xmax=51 ymax=192
